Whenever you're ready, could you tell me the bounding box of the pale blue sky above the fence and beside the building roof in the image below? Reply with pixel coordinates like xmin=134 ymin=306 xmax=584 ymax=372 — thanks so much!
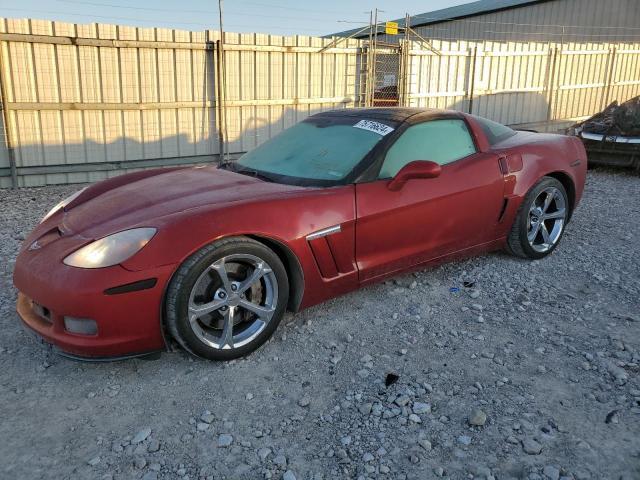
xmin=0 ymin=0 xmax=470 ymax=36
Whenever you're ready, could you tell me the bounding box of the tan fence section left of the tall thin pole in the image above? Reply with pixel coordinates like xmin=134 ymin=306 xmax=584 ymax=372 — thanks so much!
xmin=0 ymin=19 xmax=219 ymax=186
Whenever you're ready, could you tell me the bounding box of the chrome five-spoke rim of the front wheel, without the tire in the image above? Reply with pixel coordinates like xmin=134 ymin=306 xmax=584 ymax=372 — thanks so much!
xmin=189 ymin=254 xmax=278 ymax=349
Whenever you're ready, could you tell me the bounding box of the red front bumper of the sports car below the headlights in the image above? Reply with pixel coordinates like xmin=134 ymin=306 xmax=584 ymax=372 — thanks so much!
xmin=14 ymin=252 xmax=174 ymax=361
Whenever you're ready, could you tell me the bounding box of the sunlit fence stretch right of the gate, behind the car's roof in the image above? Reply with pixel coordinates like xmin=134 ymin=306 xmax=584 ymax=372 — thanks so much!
xmin=405 ymin=40 xmax=640 ymax=131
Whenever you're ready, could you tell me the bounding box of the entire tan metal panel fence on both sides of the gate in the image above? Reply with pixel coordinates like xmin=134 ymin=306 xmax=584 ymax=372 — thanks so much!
xmin=0 ymin=19 xmax=640 ymax=187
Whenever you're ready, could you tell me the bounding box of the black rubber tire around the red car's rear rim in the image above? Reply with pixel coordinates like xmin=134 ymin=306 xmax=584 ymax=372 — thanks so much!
xmin=507 ymin=177 xmax=571 ymax=260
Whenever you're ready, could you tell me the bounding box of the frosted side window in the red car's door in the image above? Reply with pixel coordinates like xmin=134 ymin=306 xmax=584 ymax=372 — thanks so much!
xmin=378 ymin=118 xmax=476 ymax=178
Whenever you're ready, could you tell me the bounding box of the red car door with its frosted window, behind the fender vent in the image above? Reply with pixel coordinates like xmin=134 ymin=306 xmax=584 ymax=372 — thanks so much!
xmin=356 ymin=118 xmax=504 ymax=281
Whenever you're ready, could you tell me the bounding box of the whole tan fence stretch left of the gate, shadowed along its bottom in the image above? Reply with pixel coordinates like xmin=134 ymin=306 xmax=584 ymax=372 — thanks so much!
xmin=0 ymin=19 xmax=360 ymax=187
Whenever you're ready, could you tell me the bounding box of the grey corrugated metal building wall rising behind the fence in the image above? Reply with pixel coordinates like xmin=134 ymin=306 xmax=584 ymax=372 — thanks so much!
xmin=396 ymin=0 xmax=640 ymax=43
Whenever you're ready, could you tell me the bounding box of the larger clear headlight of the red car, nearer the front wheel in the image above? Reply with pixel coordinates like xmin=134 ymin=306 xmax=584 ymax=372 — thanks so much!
xmin=63 ymin=228 xmax=156 ymax=268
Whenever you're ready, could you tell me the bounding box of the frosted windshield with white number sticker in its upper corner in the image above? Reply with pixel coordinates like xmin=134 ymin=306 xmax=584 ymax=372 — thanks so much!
xmin=234 ymin=117 xmax=395 ymax=185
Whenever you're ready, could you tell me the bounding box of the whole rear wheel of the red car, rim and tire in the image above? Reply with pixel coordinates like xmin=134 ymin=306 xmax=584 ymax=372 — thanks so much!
xmin=507 ymin=177 xmax=569 ymax=259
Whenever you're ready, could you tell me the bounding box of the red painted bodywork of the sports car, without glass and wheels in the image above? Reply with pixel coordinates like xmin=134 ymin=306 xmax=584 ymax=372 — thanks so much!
xmin=14 ymin=109 xmax=587 ymax=358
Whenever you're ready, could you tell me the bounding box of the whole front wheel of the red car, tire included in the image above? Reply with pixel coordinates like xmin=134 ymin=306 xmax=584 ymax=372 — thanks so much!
xmin=166 ymin=237 xmax=289 ymax=360
